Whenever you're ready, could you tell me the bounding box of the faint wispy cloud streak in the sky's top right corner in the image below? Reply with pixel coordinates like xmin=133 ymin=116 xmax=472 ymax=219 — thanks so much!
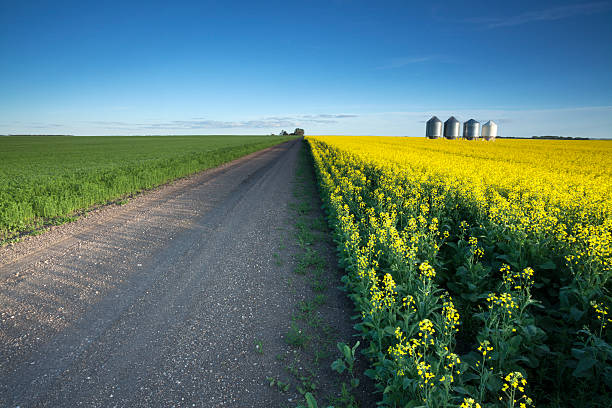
xmin=474 ymin=1 xmax=610 ymax=29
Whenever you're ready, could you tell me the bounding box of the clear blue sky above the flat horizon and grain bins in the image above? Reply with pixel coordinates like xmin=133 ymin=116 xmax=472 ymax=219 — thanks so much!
xmin=0 ymin=0 xmax=612 ymax=137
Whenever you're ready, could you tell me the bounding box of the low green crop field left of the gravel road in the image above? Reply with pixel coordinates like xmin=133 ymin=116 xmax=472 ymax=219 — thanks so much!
xmin=0 ymin=136 xmax=290 ymax=243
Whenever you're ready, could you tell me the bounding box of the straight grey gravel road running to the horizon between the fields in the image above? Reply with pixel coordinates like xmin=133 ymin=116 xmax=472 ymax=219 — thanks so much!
xmin=0 ymin=140 xmax=316 ymax=407
